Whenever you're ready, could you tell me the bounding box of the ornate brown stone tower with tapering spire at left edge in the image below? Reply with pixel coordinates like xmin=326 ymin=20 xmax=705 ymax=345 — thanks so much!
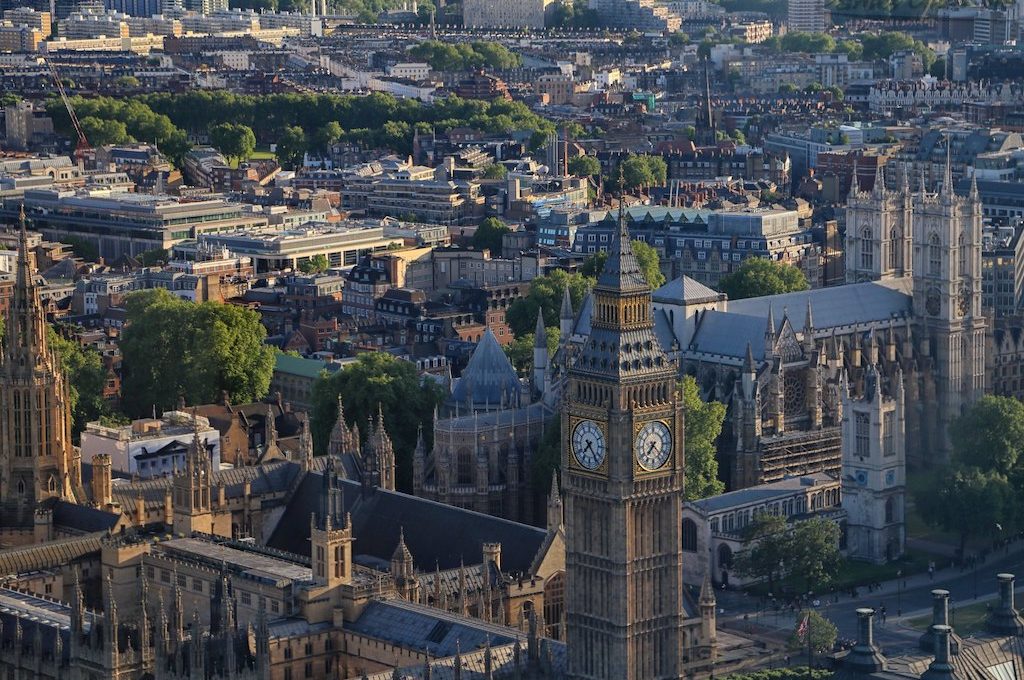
xmin=0 ymin=209 xmax=84 ymax=516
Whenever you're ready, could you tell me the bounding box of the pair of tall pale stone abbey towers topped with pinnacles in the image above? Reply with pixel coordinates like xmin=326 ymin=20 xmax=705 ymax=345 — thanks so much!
xmin=846 ymin=153 xmax=985 ymax=462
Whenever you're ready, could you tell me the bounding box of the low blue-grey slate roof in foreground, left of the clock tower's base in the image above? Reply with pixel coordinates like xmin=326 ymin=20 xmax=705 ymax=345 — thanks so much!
xmin=346 ymin=599 xmax=515 ymax=656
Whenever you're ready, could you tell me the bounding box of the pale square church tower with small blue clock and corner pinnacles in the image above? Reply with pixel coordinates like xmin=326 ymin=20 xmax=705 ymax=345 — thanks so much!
xmin=840 ymin=366 xmax=906 ymax=564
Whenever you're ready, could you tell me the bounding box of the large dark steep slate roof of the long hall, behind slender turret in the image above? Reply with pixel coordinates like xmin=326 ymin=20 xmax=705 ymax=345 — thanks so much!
xmin=267 ymin=471 xmax=547 ymax=573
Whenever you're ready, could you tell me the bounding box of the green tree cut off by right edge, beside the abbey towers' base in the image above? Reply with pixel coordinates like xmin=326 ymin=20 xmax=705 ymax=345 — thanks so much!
xmin=949 ymin=395 xmax=1024 ymax=475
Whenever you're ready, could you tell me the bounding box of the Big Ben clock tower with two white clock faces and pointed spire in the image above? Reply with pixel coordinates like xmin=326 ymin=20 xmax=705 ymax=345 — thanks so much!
xmin=562 ymin=199 xmax=683 ymax=680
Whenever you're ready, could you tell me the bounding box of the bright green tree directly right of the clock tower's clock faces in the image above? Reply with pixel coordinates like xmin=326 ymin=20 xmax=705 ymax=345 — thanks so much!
xmin=680 ymin=376 xmax=725 ymax=501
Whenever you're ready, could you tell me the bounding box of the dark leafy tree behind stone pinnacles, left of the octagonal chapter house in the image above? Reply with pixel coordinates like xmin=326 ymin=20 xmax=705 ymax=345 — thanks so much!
xmin=311 ymin=352 xmax=443 ymax=492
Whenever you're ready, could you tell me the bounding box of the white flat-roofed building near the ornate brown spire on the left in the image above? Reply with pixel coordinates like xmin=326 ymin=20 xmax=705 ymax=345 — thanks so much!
xmin=82 ymin=411 xmax=220 ymax=479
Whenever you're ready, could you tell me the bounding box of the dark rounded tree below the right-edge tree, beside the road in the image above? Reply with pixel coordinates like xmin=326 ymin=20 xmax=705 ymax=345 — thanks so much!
xmin=913 ymin=467 xmax=1020 ymax=557
